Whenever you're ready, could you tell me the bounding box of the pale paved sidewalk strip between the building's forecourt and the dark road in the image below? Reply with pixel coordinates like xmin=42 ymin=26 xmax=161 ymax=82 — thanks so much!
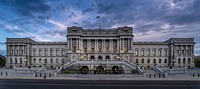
xmin=0 ymin=75 xmax=200 ymax=81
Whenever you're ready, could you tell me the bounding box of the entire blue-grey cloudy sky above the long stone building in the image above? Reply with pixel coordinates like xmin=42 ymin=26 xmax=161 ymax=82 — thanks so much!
xmin=0 ymin=0 xmax=200 ymax=55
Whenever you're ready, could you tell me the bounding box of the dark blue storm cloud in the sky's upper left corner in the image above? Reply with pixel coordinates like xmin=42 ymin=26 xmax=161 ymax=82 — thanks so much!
xmin=0 ymin=0 xmax=50 ymax=19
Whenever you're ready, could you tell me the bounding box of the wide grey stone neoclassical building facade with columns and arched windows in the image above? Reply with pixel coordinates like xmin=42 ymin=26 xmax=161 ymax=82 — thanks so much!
xmin=6 ymin=26 xmax=195 ymax=69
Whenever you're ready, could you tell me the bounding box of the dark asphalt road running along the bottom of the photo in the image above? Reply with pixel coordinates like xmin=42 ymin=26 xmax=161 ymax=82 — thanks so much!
xmin=0 ymin=79 xmax=200 ymax=89
